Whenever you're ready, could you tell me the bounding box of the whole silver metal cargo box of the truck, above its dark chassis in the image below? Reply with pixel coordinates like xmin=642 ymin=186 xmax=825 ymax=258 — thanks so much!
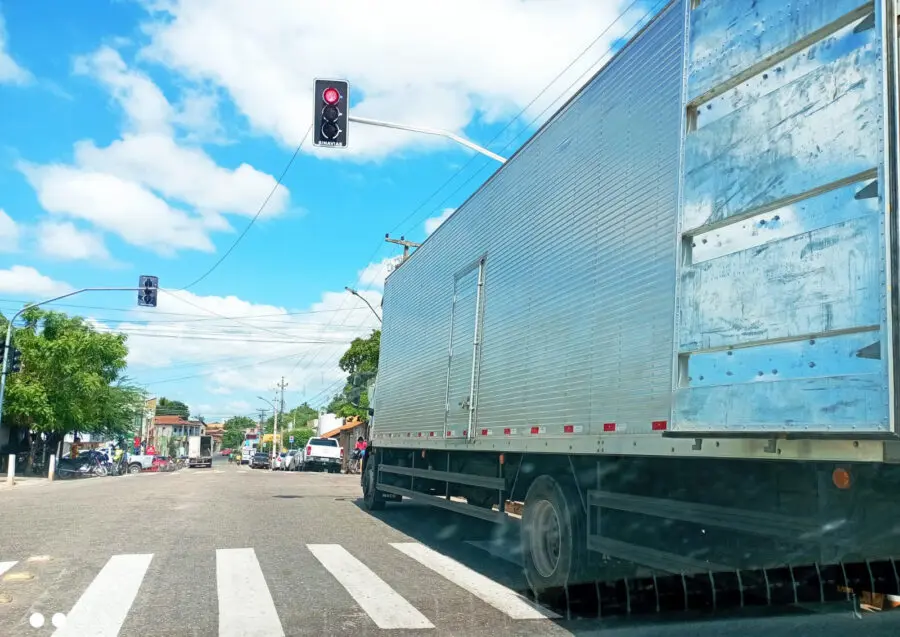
xmin=374 ymin=0 xmax=895 ymax=461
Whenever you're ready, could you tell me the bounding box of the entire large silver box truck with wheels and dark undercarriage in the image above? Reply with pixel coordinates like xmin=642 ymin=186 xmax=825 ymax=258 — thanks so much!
xmin=362 ymin=0 xmax=900 ymax=594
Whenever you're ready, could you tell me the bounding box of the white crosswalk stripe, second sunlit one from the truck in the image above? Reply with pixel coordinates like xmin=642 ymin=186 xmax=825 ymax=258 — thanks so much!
xmin=306 ymin=544 xmax=434 ymax=628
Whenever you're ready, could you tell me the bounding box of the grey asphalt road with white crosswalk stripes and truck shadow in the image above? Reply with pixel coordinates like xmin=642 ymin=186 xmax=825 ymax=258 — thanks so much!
xmin=0 ymin=462 xmax=897 ymax=637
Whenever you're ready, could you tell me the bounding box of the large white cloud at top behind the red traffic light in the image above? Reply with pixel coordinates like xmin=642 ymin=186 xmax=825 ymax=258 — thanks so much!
xmin=144 ymin=0 xmax=638 ymax=158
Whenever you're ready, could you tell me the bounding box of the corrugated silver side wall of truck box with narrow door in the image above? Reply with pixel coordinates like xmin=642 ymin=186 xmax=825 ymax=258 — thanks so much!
xmin=375 ymin=2 xmax=684 ymax=446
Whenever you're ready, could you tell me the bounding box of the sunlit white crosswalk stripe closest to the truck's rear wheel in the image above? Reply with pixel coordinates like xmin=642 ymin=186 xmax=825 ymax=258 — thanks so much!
xmin=391 ymin=542 xmax=559 ymax=619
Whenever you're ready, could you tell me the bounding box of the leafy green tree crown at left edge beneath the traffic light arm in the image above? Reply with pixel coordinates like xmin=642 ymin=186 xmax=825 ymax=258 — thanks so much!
xmin=0 ymin=308 xmax=143 ymax=437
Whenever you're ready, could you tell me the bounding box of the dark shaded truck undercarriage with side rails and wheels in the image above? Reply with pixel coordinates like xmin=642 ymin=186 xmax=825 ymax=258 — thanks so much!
xmin=362 ymin=447 xmax=900 ymax=594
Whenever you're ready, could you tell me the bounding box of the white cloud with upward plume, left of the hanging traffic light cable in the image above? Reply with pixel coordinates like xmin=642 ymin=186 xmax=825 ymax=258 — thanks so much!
xmin=20 ymin=47 xmax=289 ymax=256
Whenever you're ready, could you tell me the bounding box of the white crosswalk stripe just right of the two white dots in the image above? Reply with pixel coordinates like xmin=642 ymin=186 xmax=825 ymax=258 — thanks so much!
xmin=53 ymin=553 xmax=153 ymax=637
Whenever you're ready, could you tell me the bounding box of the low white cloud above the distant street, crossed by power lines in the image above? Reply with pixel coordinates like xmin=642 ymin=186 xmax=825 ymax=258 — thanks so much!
xmin=115 ymin=291 xmax=381 ymax=400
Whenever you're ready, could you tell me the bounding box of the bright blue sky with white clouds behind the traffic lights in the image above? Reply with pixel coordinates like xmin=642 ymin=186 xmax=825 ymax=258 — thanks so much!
xmin=0 ymin=0 xmax=646 ymax=419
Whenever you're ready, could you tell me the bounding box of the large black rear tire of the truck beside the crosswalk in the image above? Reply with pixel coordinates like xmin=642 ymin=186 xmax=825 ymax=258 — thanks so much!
xmin=522 ymin=475 xmax=588 ymax=593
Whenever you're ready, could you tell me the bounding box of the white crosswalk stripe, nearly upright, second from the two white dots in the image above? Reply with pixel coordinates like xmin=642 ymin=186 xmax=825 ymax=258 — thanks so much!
xmin=216 ymin=549 xmax=284 ymax=637
